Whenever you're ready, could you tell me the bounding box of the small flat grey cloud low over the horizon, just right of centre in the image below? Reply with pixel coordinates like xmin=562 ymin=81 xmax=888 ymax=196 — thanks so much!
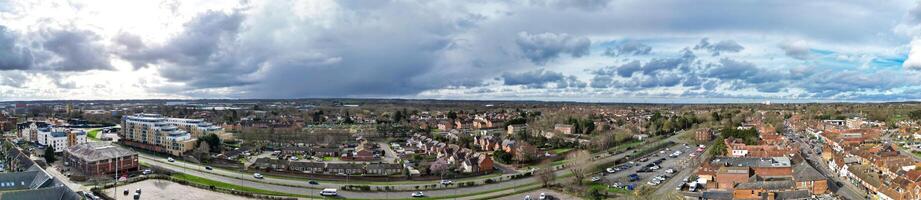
xmin=501 ymin=69 xmax=586 ymax=88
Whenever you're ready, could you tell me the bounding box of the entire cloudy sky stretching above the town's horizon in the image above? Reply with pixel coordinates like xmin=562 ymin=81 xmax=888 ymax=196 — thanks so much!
xmin=0 ymin=0 xmax=921 ymax=103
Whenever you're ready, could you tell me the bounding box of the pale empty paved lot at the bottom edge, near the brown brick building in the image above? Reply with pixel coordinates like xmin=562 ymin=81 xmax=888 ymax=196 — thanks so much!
xmin=105 ymin=180 xmax=249 ymax=200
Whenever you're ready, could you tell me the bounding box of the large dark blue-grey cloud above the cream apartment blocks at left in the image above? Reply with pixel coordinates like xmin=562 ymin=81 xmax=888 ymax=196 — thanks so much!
xmin=114 ymin=11 xmax=256 ymax=88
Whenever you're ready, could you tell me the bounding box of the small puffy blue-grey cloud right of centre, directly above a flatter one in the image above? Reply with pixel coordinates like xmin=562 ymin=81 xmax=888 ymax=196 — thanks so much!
xmin=515 ymin=32 xmax=592 ymax=65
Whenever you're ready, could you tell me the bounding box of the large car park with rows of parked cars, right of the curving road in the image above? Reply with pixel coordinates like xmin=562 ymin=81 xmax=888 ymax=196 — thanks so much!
xmin=594 ymin=143 xmax=702 ymax=192
